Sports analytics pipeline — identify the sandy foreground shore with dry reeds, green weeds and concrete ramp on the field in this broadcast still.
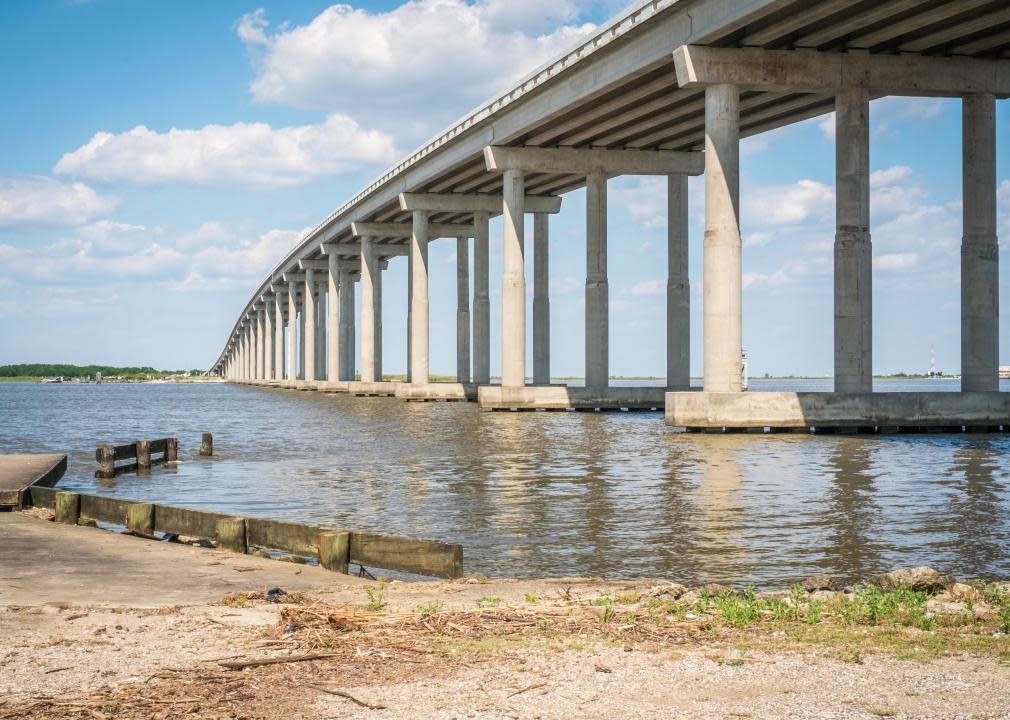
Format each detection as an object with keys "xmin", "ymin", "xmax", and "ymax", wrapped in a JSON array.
[{"xmin": 0, "ymin": 508, "xmax": 1010, "ymax": 719}]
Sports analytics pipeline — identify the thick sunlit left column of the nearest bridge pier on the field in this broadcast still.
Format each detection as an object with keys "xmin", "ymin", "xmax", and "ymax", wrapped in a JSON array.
[{"xmin": 704, "ymin": 85, "xmax": 743, "ymax": 393}]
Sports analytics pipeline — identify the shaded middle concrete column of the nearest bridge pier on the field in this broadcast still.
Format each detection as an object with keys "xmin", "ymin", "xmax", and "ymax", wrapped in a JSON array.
[{"xmin": 834, "ymin": 89, "xmax": 874, "ymax": 393}]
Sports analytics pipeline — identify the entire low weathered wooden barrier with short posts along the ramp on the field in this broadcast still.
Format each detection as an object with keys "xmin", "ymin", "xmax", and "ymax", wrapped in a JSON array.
[{"xmin": 30, "ymin": 486, "xmax": 463, "ymax": 578}]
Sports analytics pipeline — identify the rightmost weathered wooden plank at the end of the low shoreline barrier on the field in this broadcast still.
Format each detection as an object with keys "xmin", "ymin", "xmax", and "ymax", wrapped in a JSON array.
[{"xmin": 350, "ymin": 532, "xmax": 463, "ymax": 578}]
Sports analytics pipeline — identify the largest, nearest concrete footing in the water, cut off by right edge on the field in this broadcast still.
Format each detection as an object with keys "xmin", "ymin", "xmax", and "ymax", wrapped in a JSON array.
[{"xmin": 666, "ymin": 392, "xmax": 1010, "ymax": 432}]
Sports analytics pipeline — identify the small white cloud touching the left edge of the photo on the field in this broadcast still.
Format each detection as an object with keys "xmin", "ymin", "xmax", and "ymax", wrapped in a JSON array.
[{"xmin": 0, "ymin": 176, "xmax": 119, "ymax": 227}]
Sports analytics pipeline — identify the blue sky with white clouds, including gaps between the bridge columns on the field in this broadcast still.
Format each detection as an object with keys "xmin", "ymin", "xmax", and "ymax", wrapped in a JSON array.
[{"xmin": 0, "ymin": 0, "xmax": 1010, "ymax": 376}]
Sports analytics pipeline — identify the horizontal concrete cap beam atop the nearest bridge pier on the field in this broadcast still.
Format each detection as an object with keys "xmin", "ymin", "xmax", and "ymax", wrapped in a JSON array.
[{"xmin": 674, "ymin": 45, "xmax": 1010, "ymax": 97}]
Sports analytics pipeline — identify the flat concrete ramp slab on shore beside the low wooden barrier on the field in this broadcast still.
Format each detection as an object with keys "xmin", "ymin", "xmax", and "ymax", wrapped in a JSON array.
[{"xmin": 0, "ymin": 512, "xmax": 364, "ymax": 608}]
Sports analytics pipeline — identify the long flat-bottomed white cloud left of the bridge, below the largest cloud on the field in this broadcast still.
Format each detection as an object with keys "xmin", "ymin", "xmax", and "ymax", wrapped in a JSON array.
[{"xmin": 54, "ymin": 113, "xmax": 395, "ymax": 187}]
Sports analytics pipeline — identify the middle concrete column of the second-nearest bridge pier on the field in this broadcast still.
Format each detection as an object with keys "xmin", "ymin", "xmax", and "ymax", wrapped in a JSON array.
[{"xmin": 586, "ymin": 174, "xmax": 610, "ymax": 388}]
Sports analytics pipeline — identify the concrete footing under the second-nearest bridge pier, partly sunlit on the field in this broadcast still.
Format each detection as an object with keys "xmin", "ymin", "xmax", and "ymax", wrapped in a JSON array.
[{"xmin": 478, "ymin": 385, "xmax": 667, "ymax": 410}]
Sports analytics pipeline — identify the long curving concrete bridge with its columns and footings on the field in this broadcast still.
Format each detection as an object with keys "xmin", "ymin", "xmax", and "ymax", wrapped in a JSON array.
[{"xmin": 211, "ymin": 0, "xmax": 1010, "ymax": 428}]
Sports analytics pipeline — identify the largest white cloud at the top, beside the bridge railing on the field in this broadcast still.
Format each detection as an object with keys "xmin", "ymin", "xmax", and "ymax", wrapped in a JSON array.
[{"xmin": 237, "ymin": 0, "xmax": 593, "ymax": 132}]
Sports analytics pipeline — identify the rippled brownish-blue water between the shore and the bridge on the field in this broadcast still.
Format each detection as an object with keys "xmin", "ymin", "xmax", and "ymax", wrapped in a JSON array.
[{"xmin": 0, "ymin": 381, "xmax": 1010, "ymax": 587}]
